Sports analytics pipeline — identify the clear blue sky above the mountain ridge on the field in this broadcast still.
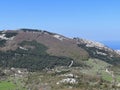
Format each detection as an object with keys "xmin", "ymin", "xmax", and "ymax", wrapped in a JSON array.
[{"xmin": 0, "ymin": 0, "xmax": 120, "ymax": 41}]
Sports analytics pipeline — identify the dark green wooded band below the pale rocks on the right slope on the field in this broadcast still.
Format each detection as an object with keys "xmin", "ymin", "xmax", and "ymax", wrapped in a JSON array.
[{"xmin": 78, "ymin": 44, "xmax": 120, "ymax": 65}]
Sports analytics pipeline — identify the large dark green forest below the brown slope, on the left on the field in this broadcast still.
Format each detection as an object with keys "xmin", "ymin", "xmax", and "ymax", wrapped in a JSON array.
[{"xmin": 0, "ymin": 41, "xmax": 81, "ymax": 71}]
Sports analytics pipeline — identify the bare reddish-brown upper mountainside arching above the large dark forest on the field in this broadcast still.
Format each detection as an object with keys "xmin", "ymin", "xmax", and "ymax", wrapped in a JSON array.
[{"xmin": 1, "ymin": 29, "xmax": 88, "ymax": 59}]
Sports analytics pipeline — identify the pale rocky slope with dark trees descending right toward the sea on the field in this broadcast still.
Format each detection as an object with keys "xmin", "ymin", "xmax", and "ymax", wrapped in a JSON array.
[{"xmin": 74, "ymin": 38, "xmax": 120, "ymax": 65}]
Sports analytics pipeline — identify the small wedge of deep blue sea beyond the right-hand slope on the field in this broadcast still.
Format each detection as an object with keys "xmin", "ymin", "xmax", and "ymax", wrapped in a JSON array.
[{"xmin": 102, "ymin": 41, "xmax": 120, "ymax": 50}]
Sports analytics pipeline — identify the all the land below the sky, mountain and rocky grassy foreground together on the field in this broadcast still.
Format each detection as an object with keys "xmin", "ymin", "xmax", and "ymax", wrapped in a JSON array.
[{"xmin": 0, "ymin": 29, "xmax": 120, "ymax": 90}]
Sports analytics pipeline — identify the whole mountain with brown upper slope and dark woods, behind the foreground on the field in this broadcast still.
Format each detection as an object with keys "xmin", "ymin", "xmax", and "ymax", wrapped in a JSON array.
[{"xmin": 0, "ymin": 29, "xmax": 120, "ymax": 70}]
